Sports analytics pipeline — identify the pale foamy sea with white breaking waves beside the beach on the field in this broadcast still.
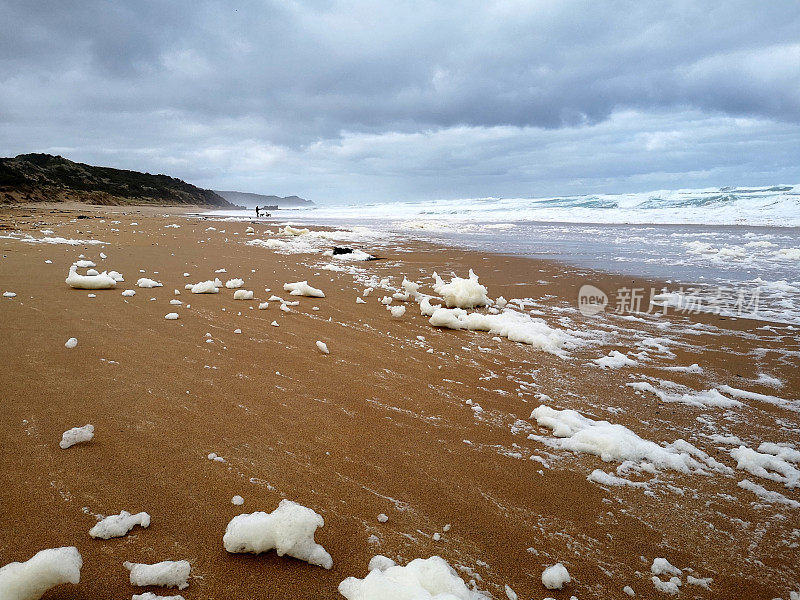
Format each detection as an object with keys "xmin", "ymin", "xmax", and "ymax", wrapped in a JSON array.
[{"xmin": 206, "ymin": 185, "xmax": 800, "ymax": 325}]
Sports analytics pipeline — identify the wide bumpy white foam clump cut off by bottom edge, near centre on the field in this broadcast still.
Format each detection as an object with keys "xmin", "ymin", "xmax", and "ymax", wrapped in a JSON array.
[{"xmin": 339, "ymin": 555, "xmax": 489, "ymax": 600}]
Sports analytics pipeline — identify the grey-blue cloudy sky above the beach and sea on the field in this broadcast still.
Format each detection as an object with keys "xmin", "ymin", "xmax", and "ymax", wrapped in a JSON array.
[{"xmin": 0, "ymin": 0, "xmax": 800, "ymax": 203}]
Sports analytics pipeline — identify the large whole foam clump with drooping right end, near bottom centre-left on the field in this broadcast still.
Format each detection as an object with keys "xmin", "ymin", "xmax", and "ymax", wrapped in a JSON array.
[{"xmin": 222, "ymin": 499, "xmax": 333, "ymax": 569}]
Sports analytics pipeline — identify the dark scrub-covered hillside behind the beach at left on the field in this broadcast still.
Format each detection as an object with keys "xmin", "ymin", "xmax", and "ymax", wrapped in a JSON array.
[{"xmin": 0, "ymin": 154, "xmax": 231, "ymax": 207}]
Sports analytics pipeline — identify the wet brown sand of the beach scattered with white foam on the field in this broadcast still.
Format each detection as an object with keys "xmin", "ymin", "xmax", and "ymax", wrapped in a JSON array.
[{"xmin": 0, "ymin": 205, "xmax": 800, "ymax": 600}]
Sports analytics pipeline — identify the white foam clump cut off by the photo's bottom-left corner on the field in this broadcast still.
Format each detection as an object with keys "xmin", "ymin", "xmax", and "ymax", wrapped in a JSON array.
[{"xmin": 0, "ymin": 546, "xmax": 83, "ymax": 600}]
